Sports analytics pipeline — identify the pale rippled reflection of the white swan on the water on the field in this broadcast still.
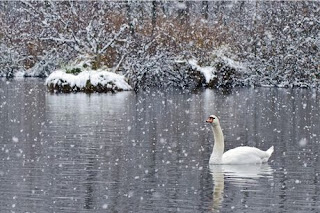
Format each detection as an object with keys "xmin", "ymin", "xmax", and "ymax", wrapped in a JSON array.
[{"xmin": 210, "ymin": 164, "xmax": 273, "ymax": 212}]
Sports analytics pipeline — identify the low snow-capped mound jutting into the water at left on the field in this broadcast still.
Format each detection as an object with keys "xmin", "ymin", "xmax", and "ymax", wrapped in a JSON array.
[{"xmin": 45, "ymin": 70, "xmax": 132, "ymax": 92}]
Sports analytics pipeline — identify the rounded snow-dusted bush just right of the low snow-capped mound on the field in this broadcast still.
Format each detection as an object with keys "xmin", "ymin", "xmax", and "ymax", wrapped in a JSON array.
[{"xmin": 124, "ymin": 53, "xmax": 205, "ymax": 90}]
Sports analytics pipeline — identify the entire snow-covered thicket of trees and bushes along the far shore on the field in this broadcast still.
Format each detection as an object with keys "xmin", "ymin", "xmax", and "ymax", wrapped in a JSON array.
[{"xmin": 0, "ymin": 0, "xmax": 320, "ymax": 88}]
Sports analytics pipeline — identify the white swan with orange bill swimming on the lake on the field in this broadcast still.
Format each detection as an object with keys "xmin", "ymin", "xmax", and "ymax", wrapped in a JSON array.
[{"xmin": 206, "ymin": 115, "xmax": 274, "ymax": 164}]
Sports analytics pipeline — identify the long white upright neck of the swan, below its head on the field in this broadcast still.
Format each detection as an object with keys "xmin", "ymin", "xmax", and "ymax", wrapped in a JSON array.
[{"xmin": 210, "ymin": 125, "xmax": 224, "ymax": 164}]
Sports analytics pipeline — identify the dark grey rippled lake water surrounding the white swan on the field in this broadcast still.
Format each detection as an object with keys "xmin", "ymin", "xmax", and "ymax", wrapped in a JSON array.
[{"xmin": 0, "ymin": 79, "xmax": 320, "ymax": 213}]
